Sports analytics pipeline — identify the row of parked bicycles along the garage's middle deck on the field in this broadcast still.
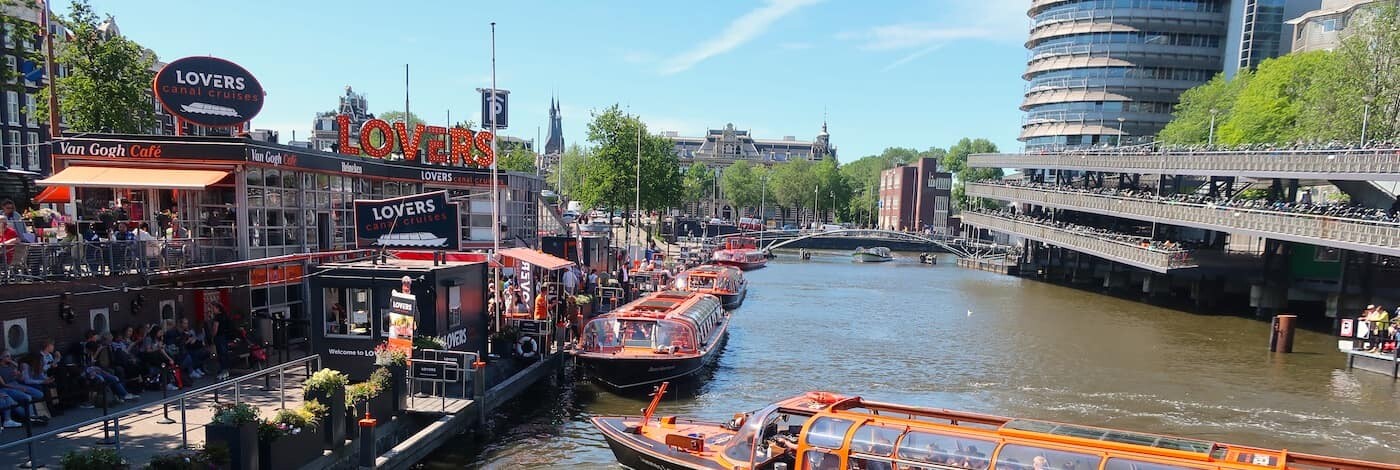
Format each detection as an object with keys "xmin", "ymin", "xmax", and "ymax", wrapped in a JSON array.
[{"xmin": 979, "ymin": 180, "xmax": 1400, "ymax": 224}]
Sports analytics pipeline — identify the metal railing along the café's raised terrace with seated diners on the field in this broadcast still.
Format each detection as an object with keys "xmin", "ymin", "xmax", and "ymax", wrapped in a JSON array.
[{"xmin": 0, "ymin": 238, "xmax": 238, "ymax": 284}]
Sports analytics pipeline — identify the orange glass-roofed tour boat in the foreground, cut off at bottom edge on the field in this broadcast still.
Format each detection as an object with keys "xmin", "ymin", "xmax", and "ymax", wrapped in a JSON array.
[{"xmin": 592, "ymin": 385, "xmax": 1400, "ymax": 470}]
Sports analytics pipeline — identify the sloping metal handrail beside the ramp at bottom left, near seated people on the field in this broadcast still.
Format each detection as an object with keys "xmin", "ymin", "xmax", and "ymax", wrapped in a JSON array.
[{"xmin": 0, "ymin": 354, "xmax": 321, "ymax": 469}]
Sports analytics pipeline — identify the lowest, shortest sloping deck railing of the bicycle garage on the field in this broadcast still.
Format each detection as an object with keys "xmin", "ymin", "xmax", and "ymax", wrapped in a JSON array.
[{"xmin": 962, "ymin": 211, "xmax": 1196, "ymax": 273}]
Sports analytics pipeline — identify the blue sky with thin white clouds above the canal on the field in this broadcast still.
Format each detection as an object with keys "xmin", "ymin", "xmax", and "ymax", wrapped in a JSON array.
[{"xmin": 84, "ymin": 0, "xmax": 1026, "ymax": 162}]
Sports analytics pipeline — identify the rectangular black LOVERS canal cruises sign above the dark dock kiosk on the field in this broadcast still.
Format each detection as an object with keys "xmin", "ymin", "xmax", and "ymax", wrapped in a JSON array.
[{"xmin": 354, "ymin": 192, "xmax": 462, "ymax": 250}]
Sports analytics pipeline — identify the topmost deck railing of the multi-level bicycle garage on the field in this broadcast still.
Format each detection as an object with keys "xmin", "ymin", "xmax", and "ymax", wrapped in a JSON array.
[{"xmin": 967, "ymin": 148, "xmax": 1400, "ymax": 180}]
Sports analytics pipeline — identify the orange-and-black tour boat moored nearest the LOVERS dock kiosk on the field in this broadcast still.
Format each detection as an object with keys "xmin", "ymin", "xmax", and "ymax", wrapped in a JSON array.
[{"xmin": 574, "ymin": 291, "xmax": 729, "ymax": 392}]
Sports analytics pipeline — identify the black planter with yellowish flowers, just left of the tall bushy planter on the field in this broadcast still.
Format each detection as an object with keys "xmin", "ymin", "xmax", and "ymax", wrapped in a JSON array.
[{"xmin": 258, "ymin": 400, "xmax": 326, "ymax": 469}]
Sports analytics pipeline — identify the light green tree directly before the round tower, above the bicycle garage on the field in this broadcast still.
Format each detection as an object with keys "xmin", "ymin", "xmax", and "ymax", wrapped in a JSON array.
[{"xmin": 1156, "ymin": 70, "xmax": 1254, "ymax": 144}]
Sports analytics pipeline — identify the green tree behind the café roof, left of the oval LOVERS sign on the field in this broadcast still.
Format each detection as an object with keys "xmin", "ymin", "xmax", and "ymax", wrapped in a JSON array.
[{"xmin": 38, "ymin": 0, "xmax": 155, "ymax": 134}]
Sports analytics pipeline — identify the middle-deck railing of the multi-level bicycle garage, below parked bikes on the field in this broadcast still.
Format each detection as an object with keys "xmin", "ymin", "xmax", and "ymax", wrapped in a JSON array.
[{"xmin": 965, "ymin": 183, "xmax": 1400, "ymax": 256}]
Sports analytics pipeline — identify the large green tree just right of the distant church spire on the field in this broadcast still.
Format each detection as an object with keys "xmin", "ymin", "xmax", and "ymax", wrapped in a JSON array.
[{"xmin": 578, "ymin": 105, "xmax": 682, "ymax": 210}]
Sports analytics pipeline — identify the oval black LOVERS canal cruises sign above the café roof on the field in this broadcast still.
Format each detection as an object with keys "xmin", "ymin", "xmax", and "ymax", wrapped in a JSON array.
[{"xmin": 155, "ymin": 56, "xmax": 263, "ymax": 127}]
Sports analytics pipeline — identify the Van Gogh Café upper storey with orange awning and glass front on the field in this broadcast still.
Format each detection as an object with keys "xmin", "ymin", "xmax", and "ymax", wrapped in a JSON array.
[{"xmin": 38, "ymin": 134, "xmax": 524, "ymax": 262}]
